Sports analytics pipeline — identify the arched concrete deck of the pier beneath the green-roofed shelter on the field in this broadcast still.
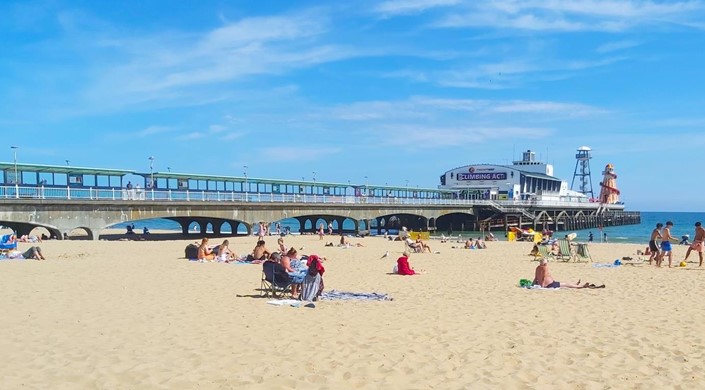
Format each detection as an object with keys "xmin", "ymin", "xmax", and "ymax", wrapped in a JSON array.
[{"xmin": 0, "ymin": 187, "xmax": 641, "ymax": 239}]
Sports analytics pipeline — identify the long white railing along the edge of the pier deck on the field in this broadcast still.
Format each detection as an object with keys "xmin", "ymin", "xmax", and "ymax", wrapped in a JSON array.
[{"xmin": 0, "ymin": 185, "xmax": 624, "ymax": 211}]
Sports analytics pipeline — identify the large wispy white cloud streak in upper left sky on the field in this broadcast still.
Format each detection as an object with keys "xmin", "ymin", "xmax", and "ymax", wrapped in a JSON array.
[{"xmin": 80, "ymin": 12, "xmax": 360, "ymax": 110}]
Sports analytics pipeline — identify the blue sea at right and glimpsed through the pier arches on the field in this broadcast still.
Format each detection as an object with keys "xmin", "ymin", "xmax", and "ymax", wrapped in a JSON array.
[{"xmin": 111, "ymin": 211, "xmax": 705, "ymax": 244}]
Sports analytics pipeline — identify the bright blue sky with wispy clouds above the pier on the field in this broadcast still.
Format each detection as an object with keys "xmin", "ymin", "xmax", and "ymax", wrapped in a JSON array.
[{"xmin": 0, "ymin": 0, "xmax": 705, "ymax": 211}]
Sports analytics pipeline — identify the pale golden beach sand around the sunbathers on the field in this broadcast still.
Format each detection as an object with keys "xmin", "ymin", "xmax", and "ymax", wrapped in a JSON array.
[{"xmin": 0, "ymin": 236, "xmax": 705, "ymax": 389}]
